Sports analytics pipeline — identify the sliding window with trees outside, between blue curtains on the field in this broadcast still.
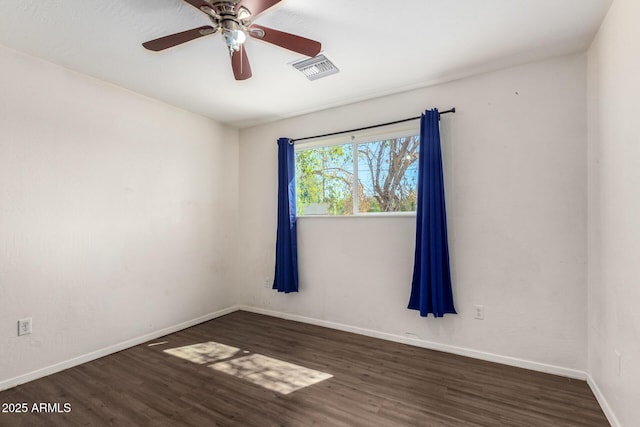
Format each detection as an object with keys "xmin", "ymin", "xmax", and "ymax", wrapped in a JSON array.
[{"xmin": 296, "ymin": 125, "xmax": 420, "ymax": 216}]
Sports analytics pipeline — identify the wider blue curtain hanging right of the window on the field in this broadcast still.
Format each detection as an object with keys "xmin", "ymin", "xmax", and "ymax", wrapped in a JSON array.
[{"xmin": 408, "ymin": 109, "xmax": 456, "ymax": 317}]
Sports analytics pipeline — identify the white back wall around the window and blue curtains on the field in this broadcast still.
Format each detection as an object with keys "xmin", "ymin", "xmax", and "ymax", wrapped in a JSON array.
[{"xmin": 239, "ymin": 55, "xmax": 587, "ymax": 374}]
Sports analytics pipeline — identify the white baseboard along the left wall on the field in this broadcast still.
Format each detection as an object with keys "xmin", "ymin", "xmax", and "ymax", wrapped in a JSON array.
[{"xmin": 0, "ymin": 306, "xmax": 239, "ymax": 391}]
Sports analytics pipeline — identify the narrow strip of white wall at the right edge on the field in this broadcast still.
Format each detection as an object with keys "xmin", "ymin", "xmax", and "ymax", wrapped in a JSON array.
[{"xmin": 588, "ymin": 0, "xmax": 640, "ymax": 426}]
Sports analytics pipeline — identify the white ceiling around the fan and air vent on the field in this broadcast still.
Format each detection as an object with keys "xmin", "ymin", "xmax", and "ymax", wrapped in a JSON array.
[{"xmin": 0, "ymin": 0, "xmax": 611, "ymax": 127}]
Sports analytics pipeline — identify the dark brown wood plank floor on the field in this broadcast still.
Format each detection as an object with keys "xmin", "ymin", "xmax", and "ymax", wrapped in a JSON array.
[{"xmin": 0, "ymin": 312, "xmax": 609, "ymax": 427}]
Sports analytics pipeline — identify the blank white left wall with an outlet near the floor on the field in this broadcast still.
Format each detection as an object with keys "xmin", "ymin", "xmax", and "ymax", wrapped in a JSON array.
[{"xmin": 0, "ymin": 47, "xmax": 238, "ymax": 388}]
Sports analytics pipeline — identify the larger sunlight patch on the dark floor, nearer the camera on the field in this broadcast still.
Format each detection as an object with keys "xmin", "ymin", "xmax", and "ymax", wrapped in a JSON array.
[{"xmin": 210, "ymin": 354, "xmax": 333, "ymax": 394}]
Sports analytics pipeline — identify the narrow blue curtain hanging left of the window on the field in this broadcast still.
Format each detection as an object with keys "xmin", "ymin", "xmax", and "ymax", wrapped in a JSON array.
[{"xmin": 273, "ymin": 138, "xmax": 298, "ymax": 294}]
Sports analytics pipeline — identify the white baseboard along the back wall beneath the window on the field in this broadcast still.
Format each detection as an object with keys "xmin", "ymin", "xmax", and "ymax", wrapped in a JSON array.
[{"xmin": 238, "ymin": 305, "xmax": 587, "ymax": 380}]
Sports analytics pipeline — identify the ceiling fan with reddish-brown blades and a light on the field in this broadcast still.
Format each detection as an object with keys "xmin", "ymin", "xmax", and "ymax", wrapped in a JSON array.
[{"xmin": 142, "ymin": 0, "xmax": 322, "ymax": 80}]
